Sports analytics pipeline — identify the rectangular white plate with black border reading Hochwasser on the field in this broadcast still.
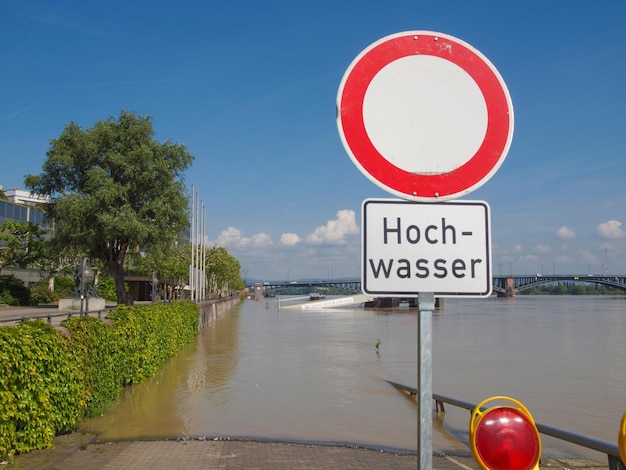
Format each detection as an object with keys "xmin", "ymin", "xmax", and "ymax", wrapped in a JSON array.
[{"xmin": 361, "ymin": 199, "xmax": 492, "ymax": 297}]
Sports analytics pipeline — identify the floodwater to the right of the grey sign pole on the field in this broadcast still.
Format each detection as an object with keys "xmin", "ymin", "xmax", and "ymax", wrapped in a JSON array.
[{"xmin": 433, "ymin": 296, "xmax": 626, "ymax": 461}]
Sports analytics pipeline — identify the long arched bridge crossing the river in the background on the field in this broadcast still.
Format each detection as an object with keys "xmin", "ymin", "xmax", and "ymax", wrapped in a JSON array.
[{"xmin": 249, "ymin": 274, "xmax": 626, "ymax": 297}]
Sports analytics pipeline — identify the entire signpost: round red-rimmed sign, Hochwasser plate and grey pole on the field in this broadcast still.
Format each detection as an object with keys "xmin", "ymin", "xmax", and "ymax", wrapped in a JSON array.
[{"xmin": 337, "ymin": 31, "xmax": 514, "ymax": 469}]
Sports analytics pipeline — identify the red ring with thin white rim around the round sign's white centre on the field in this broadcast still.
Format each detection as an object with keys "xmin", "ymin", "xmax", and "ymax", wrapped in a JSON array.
[{"xmin": 337, "ymin": 31, "xmax": 513, "ymax": 202}]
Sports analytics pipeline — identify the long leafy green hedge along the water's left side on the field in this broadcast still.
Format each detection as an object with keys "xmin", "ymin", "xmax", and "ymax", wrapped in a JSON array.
[{"xmin": 0, "ymin": 302, "xmax": 198, "ymax": 457}]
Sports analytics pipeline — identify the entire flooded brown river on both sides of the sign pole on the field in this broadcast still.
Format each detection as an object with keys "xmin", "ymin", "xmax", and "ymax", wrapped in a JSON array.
[{"xmin": 82, "ymin": 296, "xmax": 626, "ymax": 460}]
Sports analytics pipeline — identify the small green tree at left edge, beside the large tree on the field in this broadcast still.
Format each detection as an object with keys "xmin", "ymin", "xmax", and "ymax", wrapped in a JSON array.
[{"xmin": 0, "ymin": 220, "xmax": 46, "ymax": 268}]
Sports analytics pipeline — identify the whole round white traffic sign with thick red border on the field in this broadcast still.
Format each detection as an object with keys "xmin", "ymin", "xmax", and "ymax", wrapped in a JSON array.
[{"xmin": 337, "ymin": 31, "xmax": 513, "ymax": 202}]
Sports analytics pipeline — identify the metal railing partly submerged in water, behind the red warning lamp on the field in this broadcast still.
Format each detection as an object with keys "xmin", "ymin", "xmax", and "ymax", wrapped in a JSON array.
[{"xmin": 387, "ymin": 380, "xmax": 626, "ymax": 470}]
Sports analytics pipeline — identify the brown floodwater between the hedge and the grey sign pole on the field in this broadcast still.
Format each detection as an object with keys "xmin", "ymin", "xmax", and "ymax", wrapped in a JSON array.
[{"xmin": 81, "ymin": 301, "xmax": 418, "ymax": 451}]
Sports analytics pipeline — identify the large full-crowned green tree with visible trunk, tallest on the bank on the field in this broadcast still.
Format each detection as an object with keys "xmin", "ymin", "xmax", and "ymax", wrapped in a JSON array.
[{"xmin": 25, "ymin": 111, "xmax": 193, "ymax": 304}]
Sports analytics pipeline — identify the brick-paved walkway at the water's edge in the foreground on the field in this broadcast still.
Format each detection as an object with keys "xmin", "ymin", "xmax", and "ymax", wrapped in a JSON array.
[{"xmin": 6, "ymin": 433, "xmax": 608, "ymax": 470}]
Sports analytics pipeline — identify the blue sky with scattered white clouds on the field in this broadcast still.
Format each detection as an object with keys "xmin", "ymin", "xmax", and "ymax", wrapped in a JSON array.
[{"xmin": 0, "ymin": 0, "xmax": 626, "ymax": 280}]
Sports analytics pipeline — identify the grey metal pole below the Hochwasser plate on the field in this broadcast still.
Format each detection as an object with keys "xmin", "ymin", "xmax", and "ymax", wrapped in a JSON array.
[{"xmin": 417, "ymin": 292, "xmax": 435, "ymax": 470}]
